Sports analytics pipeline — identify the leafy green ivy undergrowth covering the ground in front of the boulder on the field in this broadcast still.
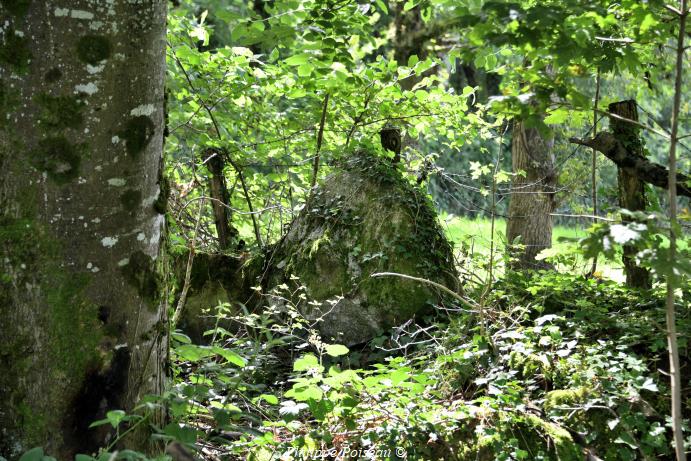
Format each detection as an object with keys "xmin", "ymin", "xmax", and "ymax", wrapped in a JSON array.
[{"xmin": 14, "ymin": 272, "xmax": 691, "ymax": 461}]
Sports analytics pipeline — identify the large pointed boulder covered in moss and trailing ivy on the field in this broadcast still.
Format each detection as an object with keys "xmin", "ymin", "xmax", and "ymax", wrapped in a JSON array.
[{"xmin": 270, "ymin": 152, "xmax": 457, "ymax": 344}]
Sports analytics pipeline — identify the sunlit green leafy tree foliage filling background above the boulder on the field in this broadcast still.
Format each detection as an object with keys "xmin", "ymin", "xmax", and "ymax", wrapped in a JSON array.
[{"xmin": 167, "ymin": 1, "xmax": 689, "ymax": 255}]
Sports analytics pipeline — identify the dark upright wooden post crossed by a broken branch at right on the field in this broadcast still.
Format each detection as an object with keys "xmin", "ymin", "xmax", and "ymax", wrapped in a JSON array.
[{"xmin": 608, "ymin": 100, "xmax": 651, "ymax": 289}]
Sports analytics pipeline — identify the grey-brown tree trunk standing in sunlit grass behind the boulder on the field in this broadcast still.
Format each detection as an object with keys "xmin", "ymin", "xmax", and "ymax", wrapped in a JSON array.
[{"xmin": 506, "ymin": 121, "xmax": 556, "ymax": 269}]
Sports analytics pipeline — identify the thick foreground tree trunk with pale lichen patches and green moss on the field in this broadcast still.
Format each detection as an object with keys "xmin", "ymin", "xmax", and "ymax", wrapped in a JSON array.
[{"xmin": 0, "ymin": 0, "xmax": 167, "ymax": 460}]
